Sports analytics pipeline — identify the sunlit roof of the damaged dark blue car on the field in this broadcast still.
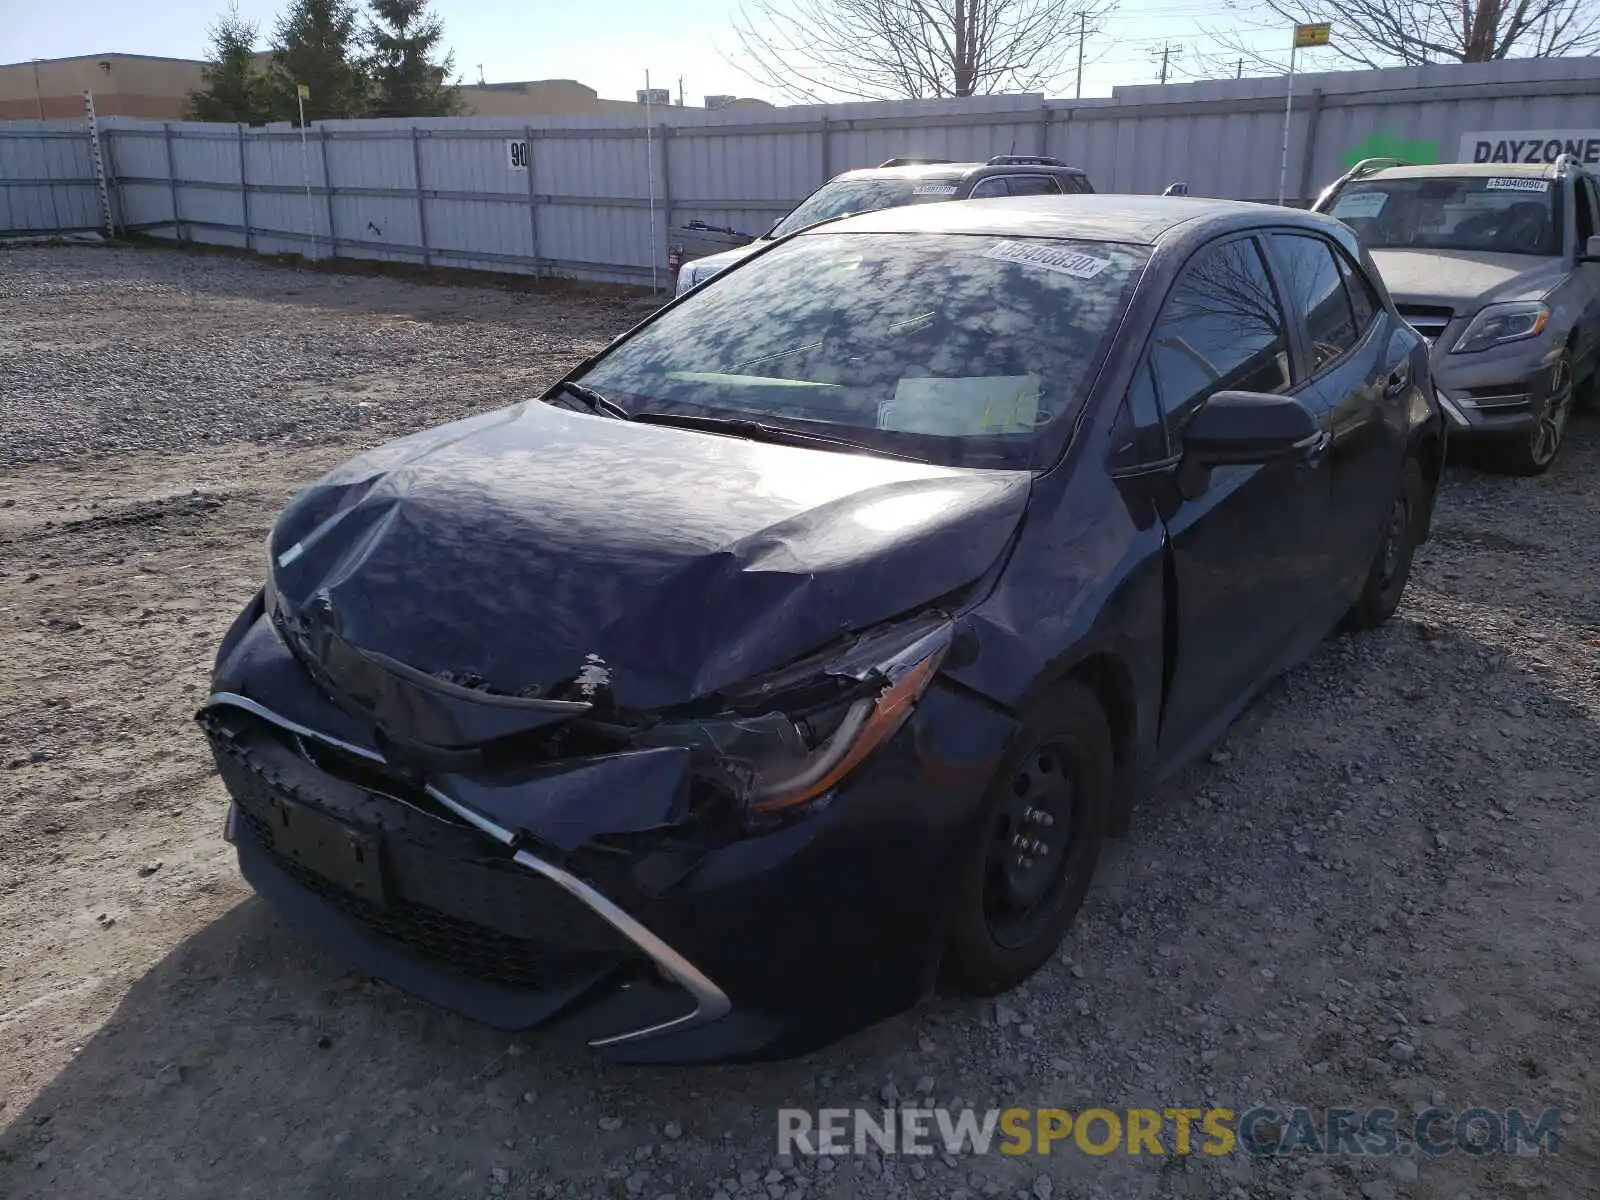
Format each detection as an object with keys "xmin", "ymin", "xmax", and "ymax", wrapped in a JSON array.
[{"xmin": 812, "ymin": 195, "xmax": 1338, "ymax": 245}]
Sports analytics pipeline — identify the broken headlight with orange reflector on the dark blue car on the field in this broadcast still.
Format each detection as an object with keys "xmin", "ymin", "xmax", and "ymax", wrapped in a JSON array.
[{"xmin": 638, "ymin": 614, "xmax": 954, "ymax": 813}]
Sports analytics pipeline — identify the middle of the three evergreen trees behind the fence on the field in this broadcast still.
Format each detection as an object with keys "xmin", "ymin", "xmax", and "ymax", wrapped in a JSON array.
[{"xmin": 269, "ymin": 0, "xmax": 371, "ymax": 122}]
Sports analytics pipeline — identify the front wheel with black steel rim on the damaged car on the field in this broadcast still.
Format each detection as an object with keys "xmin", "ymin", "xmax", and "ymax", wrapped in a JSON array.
[{"xmin": 942, "ymin": 683, "xmax": 1114, "ymax": 995}]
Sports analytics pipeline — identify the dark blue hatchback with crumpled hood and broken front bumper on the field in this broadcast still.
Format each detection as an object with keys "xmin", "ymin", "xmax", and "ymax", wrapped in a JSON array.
[{"xmin": 198, "ymin": 195, "xmax": 1445, "ymax": 1062}]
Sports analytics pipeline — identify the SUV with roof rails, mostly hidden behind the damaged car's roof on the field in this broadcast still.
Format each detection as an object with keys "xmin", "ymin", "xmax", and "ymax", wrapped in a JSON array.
[{"xmin": 677, "ymin": 154, "xmax": 1094, "ymax": 296}]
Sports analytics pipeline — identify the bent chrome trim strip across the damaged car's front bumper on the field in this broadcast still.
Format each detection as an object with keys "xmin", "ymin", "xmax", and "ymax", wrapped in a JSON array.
[{"xmin": 206, "ymin": 691, "xmax": 733, "ymax": 1048}]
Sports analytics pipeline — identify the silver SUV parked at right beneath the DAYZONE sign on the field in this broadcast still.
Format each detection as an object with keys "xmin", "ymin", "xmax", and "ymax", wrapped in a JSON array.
[{"xmin": 1312, "ymin": 155, "xmax": 1600, "ymax": 475}]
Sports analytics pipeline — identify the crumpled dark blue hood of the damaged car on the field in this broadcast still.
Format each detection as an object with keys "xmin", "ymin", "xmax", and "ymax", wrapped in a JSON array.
[{"xmin": 270, "ymin": 402, "xmax": 1030, "ymax": 710}]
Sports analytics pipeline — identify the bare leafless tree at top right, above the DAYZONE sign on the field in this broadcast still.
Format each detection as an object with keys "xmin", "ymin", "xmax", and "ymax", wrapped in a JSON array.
[{"xmin": 1206, "ymin": 0, "xmax": 1600, "ymax": 75}]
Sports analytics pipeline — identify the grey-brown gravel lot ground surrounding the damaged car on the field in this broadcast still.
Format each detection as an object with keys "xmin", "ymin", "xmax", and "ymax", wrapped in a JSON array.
[{"xmin": 0, "ymin": 248, "xmax": 1600, "ymax": 1200}]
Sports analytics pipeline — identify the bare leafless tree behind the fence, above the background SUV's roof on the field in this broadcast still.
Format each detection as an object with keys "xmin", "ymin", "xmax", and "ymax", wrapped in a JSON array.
[{"xmin": 730, "ymin": 0, "xmax": 1115, "ymax": 101}]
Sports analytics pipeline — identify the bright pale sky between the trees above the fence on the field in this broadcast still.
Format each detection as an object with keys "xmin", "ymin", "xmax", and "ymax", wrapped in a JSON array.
[{"xmin": 0, "ymin": 0, "xmax": 1305, "ymax": 104}]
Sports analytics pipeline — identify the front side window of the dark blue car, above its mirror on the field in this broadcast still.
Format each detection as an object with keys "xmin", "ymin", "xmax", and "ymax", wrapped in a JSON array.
[{"xmin": 1149, "ymin": 237, "xmax": 1291, "ymax": 434}]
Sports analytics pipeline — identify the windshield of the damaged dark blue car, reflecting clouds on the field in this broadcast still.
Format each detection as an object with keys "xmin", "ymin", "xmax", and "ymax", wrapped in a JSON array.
[{"xmin": 582, "ymin": 234, "xmax": 1147, "ymax": 469}]
